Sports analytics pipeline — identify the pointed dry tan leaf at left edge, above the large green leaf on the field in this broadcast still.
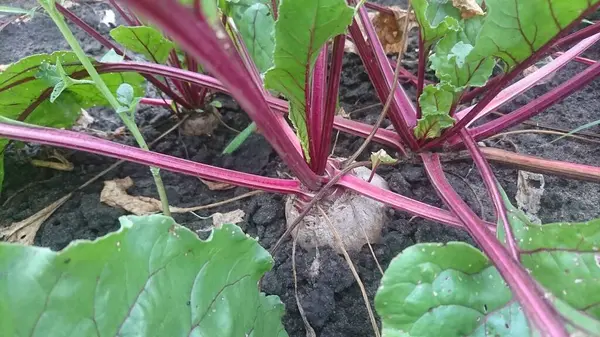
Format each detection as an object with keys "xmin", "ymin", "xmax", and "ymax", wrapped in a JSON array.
[{"xmin": 0, "ymin": 193, "xmax": 71, "ymax": 246}]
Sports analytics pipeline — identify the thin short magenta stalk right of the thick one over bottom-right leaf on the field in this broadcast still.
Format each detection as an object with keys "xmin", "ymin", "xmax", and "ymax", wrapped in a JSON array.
[{"xmin": 460, "ymin": 129, "xmax": 519, "ymax": 261}]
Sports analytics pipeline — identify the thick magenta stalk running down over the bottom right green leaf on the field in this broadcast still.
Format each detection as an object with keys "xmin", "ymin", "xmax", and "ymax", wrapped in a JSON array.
[{"xmin": 421, "ymin": 153, "xmax": 569, "ymax": 337}]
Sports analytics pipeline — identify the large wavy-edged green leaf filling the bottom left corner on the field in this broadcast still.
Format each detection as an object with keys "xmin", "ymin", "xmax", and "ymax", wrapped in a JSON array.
[{"xmin": 0, "ymin": 215, "xmax": 287, "ymax": 337}]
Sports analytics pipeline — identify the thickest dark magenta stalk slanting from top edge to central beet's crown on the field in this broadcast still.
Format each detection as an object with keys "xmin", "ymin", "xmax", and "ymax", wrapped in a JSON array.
[{"xmin": 119, "ymin": 0, "xmax": 321, "ymax": 190}]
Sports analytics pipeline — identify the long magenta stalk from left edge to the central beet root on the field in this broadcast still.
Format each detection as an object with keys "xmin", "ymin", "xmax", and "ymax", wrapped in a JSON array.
[{"xmin": 0, "ymin": 123, "xmax": 310, "ymax": 197}]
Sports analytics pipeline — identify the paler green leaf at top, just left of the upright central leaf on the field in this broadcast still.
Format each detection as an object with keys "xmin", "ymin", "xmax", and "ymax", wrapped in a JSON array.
[{"xmin": 221, "ymin": 0, "xmax": 275, "ymax": 74}]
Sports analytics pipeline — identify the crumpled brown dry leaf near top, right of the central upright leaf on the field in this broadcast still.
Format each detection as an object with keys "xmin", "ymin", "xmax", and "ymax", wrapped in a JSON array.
[{"xmin": 371, "ymin": 6, "xmax": 417, "ymax": 54}]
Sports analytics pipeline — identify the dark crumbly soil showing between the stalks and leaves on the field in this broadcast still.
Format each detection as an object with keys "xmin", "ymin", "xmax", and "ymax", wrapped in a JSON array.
[{"xmin": 0, "ymin": 1, "xmax": 600, "ymax": 337}]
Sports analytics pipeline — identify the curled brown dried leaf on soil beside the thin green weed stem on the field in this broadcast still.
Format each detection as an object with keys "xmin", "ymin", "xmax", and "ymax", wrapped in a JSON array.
[{"xmin": 100, "ymin": 177, "xmax": 162, "ymax": 215}]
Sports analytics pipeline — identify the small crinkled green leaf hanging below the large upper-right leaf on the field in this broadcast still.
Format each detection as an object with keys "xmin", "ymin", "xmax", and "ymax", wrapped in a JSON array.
[{"xmin": 414, "ymin": 84, "xmax": 456, "ymax": 139}]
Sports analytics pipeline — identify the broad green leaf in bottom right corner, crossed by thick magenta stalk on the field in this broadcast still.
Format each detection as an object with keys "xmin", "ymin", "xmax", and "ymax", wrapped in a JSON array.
[{"xmin": 375, "ymin": 190, "xmax": 600, "ymax": 337}]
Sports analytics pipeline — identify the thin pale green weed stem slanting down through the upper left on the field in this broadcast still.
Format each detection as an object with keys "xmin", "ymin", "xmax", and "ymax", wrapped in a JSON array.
[{"xmin": 39, "ymin": 0, "xmax": 171, "ymax": 216}]
